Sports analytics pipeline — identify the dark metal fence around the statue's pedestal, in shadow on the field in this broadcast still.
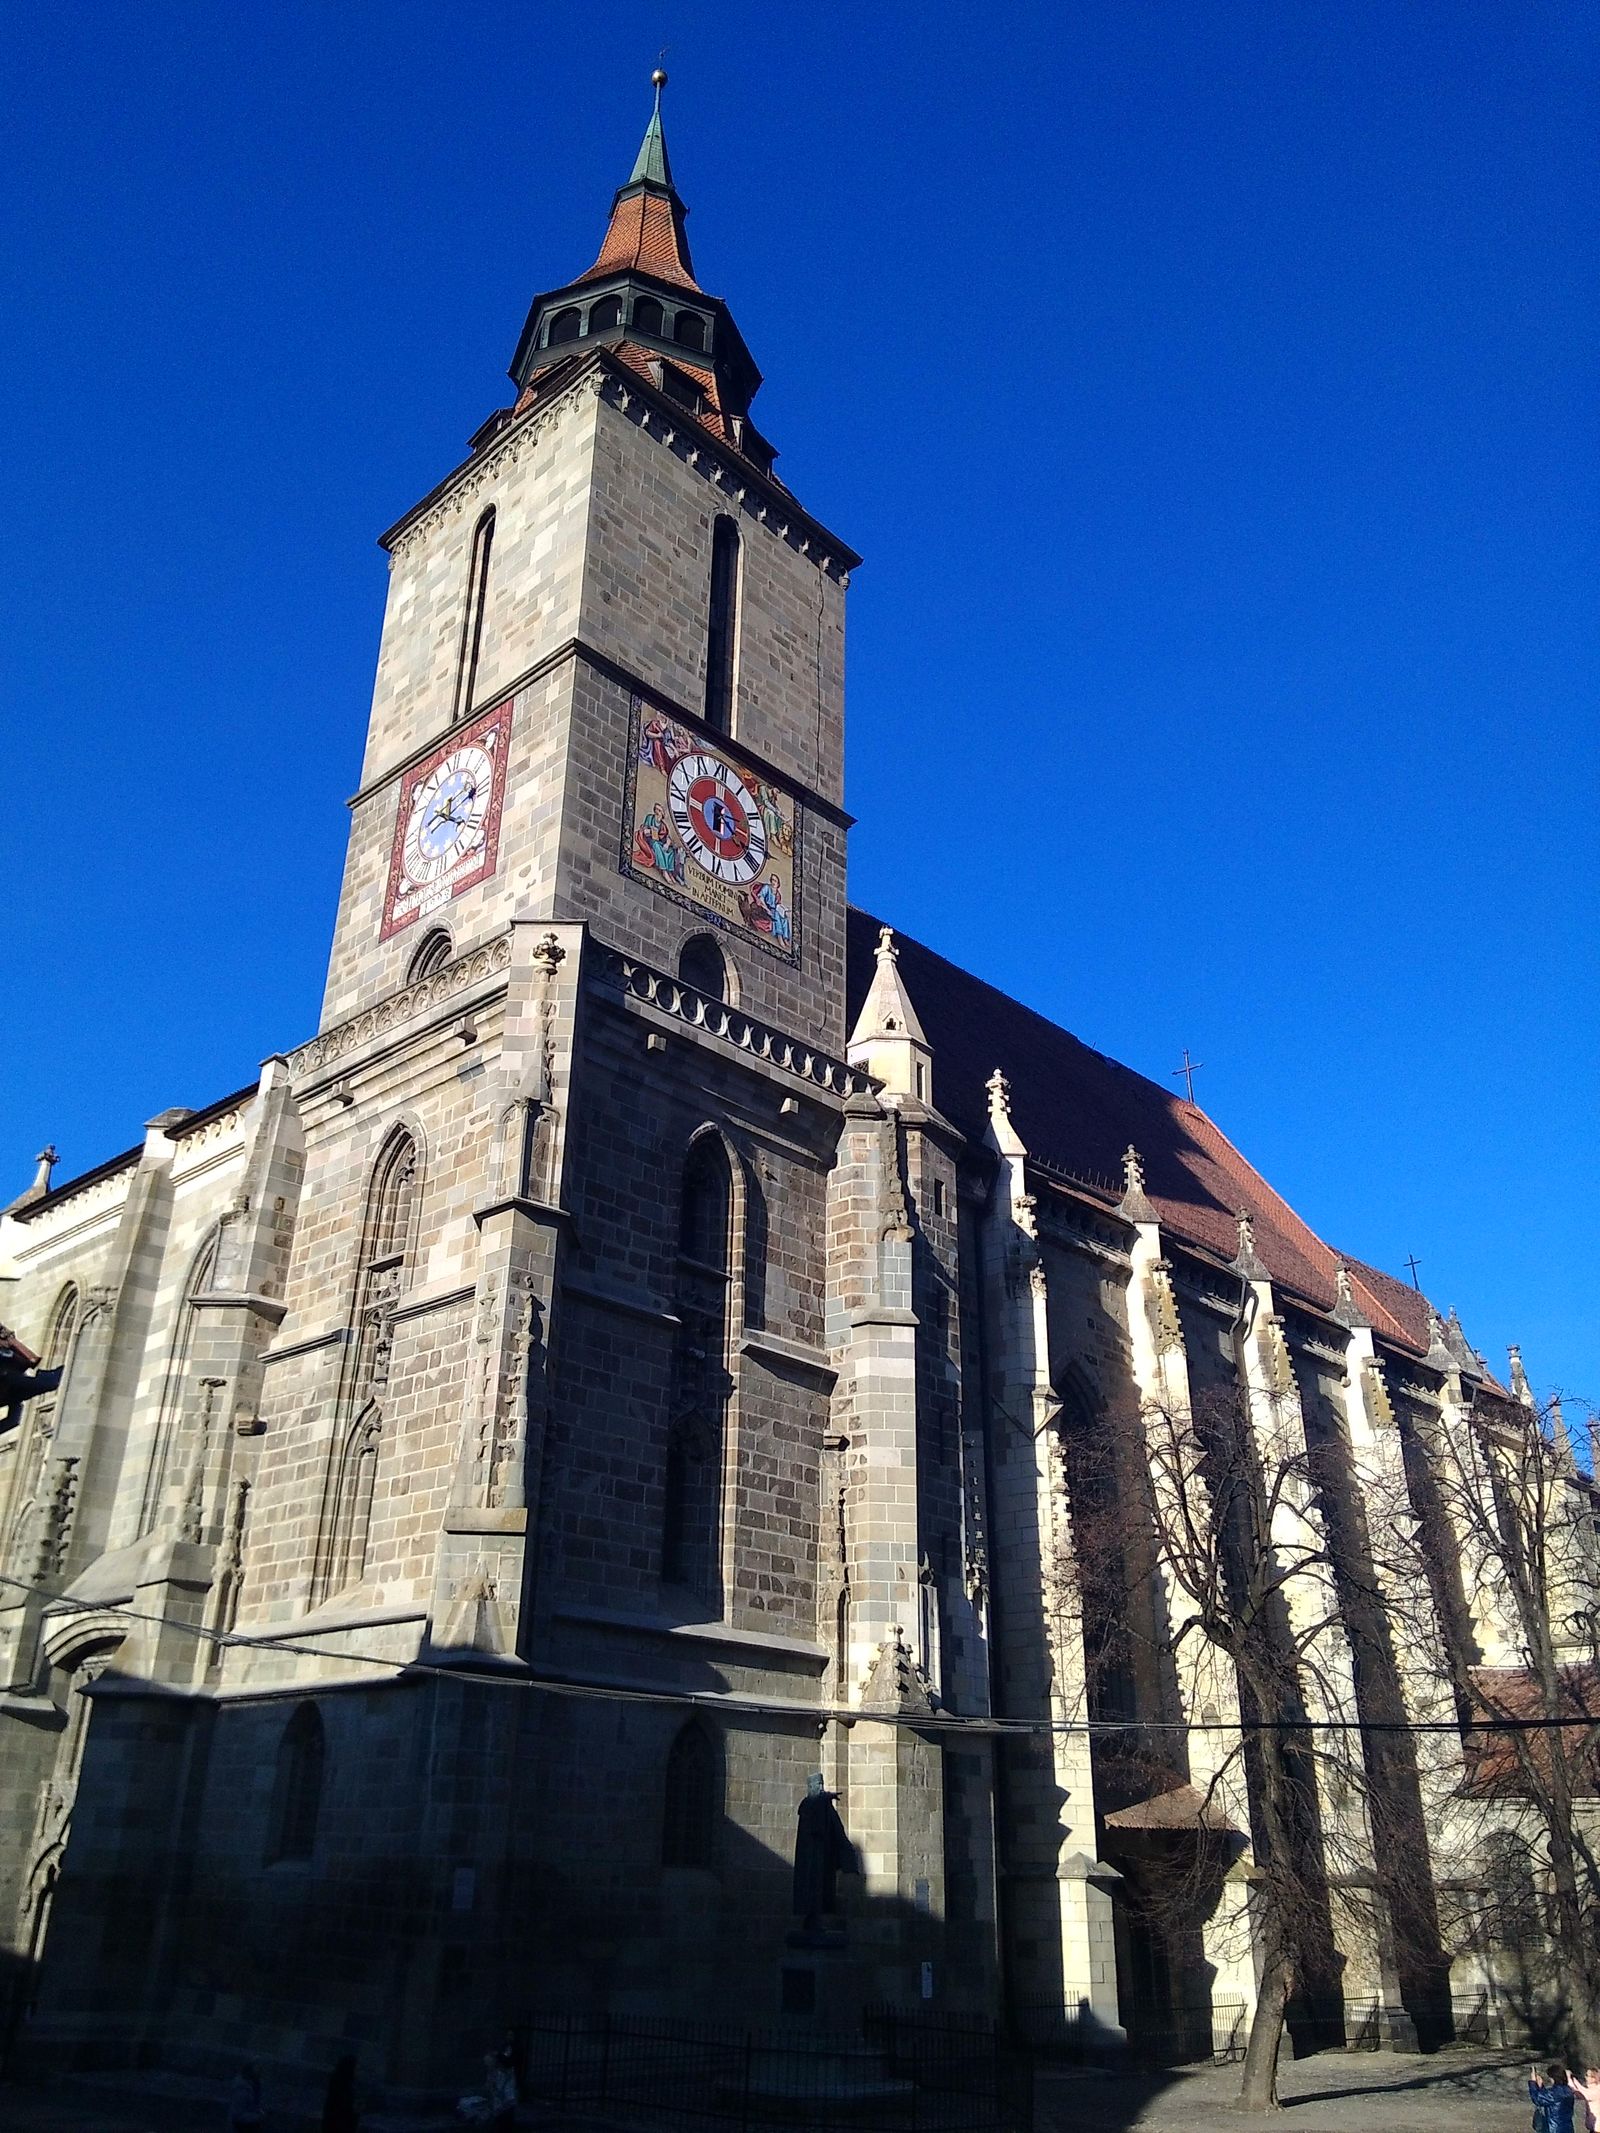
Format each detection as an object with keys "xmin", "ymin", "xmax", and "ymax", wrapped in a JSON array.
[{"xmin": 518, "ymin": 2007, "xmax": 1033, "ymax": 2133}]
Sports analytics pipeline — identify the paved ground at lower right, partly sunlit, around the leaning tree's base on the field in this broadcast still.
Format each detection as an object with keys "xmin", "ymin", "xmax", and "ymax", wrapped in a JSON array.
[{"xmin": 1037, "ymin": 2052, "xmax": 1530, "ymax": 2133}]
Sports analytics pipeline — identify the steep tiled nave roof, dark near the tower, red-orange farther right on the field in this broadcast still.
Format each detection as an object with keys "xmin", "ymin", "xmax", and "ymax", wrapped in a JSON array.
[{"xmin": 849, "ymin": 911, "xmax": 1431, "ymax": 1354}]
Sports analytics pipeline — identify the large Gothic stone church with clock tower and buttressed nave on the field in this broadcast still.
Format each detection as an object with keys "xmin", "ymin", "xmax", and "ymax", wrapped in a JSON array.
[{"xmin": 0, "ymin": 75, "xmax": 1577, "ymax": 2092}]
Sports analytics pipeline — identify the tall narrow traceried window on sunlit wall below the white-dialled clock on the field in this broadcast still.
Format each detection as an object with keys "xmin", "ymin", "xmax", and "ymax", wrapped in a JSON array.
[{"xmin": 311, "ymin": 1126, "xmax": 416, "ymax": 1606}]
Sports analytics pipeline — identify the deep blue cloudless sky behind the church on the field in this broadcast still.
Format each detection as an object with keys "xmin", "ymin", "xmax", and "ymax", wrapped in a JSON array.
[{"xmin": 0, "ymin": 12, "xmax": 1600, "ymax": 1397}]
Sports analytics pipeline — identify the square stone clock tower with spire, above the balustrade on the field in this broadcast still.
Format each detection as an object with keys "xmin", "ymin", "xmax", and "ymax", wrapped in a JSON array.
[{"xmin": 324, "ymin": 75, "xmax": 858, "ymax": 1052}]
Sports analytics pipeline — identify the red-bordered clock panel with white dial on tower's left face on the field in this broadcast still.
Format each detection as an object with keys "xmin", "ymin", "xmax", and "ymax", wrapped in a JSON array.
[{"xmin": 380, "ymin": 704, "xmax": 512, "ymax": 941}]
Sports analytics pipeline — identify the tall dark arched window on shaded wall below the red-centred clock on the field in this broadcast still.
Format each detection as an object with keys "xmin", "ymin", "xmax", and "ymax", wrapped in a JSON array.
[{"xmin": 661, "ymin": 1133, "xmax": 734, "ymax": 1615}]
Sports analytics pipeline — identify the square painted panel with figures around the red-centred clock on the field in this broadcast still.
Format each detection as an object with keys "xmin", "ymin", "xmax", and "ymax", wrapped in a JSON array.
[{"xmin": 621, "ymin": 695, "xmax": 800, "ymax": 962}]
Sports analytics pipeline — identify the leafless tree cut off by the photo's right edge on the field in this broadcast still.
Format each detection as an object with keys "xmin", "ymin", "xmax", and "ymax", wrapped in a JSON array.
[{"xmin": 1410, "ymin": 1367, "xmax": 1600, "ymax": 2058}]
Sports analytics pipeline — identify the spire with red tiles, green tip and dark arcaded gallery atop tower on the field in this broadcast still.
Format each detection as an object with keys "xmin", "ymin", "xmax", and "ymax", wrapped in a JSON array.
[{"xmin": 501, "ymin": 78, "xmax": 777, "ymax": 474}]
